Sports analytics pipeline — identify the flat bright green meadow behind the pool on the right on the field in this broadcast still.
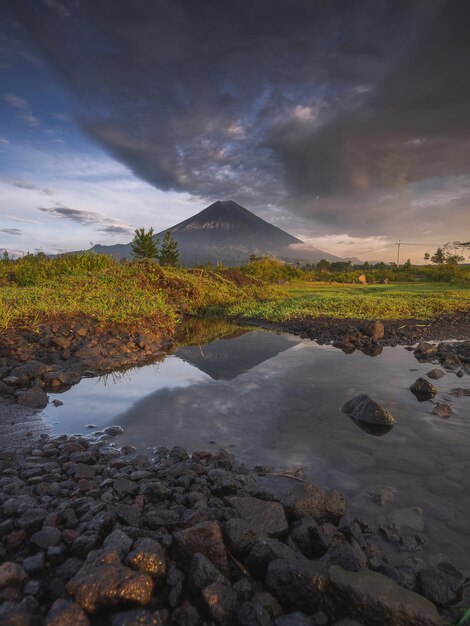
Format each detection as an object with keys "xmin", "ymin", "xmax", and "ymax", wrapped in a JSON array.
[{"xmin": 226, "ymin": 281, "xmax": 470, "ymax": 322}]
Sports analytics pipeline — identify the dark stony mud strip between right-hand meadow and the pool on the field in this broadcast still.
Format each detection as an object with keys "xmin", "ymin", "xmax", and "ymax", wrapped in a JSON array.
[{"xmin": 246, "ymin": 311, "xmax": 470, "ymax": 356}]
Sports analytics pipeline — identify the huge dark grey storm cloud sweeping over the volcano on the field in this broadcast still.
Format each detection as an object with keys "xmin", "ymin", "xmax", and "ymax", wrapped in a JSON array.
[{"xmin": 7, "ymin": 0, "xmax": 470, "ymax": 234}]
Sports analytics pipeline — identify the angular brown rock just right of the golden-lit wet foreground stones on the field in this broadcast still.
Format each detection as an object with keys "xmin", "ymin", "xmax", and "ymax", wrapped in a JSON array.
[{"xmin": 171, "ymin": 521, "xmax": 229, "ymax": 574}]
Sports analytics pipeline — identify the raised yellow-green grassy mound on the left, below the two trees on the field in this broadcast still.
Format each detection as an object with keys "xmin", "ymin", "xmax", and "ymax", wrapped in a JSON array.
[{"xmin": 0, "ymin": 255, "xmax": 272, "ymax": 331}]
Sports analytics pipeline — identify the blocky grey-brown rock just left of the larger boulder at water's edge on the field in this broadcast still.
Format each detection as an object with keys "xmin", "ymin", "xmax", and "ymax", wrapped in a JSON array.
[{"xmin": 228, "ymin": 497, "xmax": 289, "ymax": 538}]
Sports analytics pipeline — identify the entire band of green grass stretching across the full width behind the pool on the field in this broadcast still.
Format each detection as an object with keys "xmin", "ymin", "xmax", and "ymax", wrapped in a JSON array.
[{"xmin": 0, "ymin": 254, "xmax": 470, "ymax": 332}]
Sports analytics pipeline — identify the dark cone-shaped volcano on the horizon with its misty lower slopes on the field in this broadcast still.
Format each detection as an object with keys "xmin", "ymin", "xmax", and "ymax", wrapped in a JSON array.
[{"xmin": 92, "ymin": 200, "xmax": 360, "ymax": 265}]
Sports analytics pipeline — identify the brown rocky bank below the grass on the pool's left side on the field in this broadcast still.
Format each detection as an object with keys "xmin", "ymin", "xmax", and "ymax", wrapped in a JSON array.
[{"xmin": 0, "ymin": 316, "xmax": 174, "ymax": 408}]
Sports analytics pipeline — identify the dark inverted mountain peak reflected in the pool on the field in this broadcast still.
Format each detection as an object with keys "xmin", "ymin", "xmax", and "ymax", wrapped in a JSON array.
[{"xmin": 176, "ymin": 331, "xmax": 300, "ymax": 380}]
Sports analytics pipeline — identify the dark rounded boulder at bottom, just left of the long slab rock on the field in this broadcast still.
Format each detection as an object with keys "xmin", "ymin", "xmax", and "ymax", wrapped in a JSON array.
[{"xmin": 266, "ymin": 559, "xmax": 324, "ymax": 614}]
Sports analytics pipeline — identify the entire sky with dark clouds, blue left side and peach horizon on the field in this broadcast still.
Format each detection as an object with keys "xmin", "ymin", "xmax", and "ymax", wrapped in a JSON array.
[{"xmin": 0, "ymin": 0, "xmax": 470, "ymax": 260}]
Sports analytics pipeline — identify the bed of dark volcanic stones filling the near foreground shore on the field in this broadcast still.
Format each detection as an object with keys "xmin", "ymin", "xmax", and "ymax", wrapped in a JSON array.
[{"xmin": 0, "ymin": 435, "xmax": 468, "ymax": 626}]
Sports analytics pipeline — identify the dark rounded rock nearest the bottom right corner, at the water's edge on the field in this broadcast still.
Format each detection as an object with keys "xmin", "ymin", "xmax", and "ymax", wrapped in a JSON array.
[{"xmin": 418, "ymin": 563, "xmax": 465, "ymax": 606}]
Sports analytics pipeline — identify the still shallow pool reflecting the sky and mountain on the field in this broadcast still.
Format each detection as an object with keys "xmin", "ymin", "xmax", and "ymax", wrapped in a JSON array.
[{"xmin": 44, "ymin": 329, "xmax": 470, "ymax": 571}]
